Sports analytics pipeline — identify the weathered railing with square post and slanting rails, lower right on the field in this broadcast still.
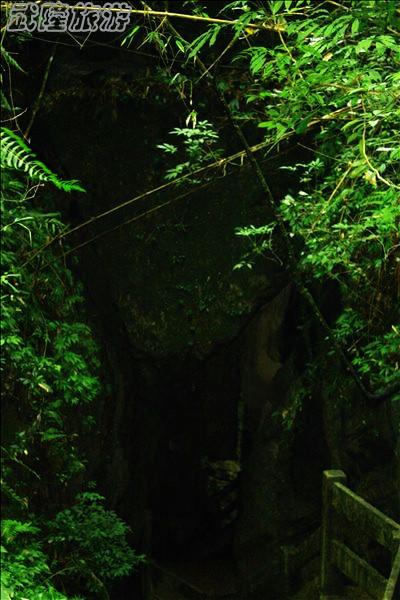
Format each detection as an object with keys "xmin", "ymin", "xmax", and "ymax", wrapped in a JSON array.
[{"xmin": 320, "ymin": 471, "xmax": 400, "ymax": 600}]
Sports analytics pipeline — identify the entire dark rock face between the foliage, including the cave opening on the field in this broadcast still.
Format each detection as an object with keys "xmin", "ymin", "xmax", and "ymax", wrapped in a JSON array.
[{"xmin": 28, "ymin": 41, "xmax": 400, "ymax": 598}]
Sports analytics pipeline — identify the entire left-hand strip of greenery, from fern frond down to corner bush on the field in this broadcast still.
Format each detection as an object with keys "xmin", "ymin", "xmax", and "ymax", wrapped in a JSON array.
[{"xmin": 0, "ymin": 43, "xmax": 142, "ymax": 600}]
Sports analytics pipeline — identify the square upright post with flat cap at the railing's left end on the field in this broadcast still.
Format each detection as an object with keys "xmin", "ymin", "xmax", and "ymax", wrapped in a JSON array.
[{"xmin": 320, "ymin": 470, "xmax": 347, "ymax": 600}]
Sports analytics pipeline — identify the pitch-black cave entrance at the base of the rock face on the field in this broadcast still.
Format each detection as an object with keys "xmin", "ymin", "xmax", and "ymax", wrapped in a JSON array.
[{"xmin": 149, "ymin": 347, "xmax": 240, "ymax": 564}]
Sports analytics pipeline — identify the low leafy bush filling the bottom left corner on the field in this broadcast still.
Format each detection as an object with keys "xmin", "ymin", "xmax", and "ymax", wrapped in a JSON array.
[{"xmin": 1, "ymin": 492, "xmax": 144, "ymax": 600}]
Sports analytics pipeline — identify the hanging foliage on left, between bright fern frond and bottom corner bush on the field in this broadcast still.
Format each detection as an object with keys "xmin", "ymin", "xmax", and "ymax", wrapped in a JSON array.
[{"xmin": 1, "ymin": 164, "xmax": 99, "ymax": 496}]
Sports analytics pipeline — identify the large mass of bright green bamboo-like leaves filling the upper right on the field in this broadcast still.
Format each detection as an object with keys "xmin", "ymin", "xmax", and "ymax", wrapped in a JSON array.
[{"xmin": 126, "ymin": 0, "xmax": 400, "ymax": 410}]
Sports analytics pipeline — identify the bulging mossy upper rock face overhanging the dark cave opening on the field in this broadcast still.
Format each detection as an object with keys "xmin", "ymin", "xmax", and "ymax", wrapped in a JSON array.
[{"xmin": 36, "ymin": 44, "xmax": 288, "ymax": 488}]
